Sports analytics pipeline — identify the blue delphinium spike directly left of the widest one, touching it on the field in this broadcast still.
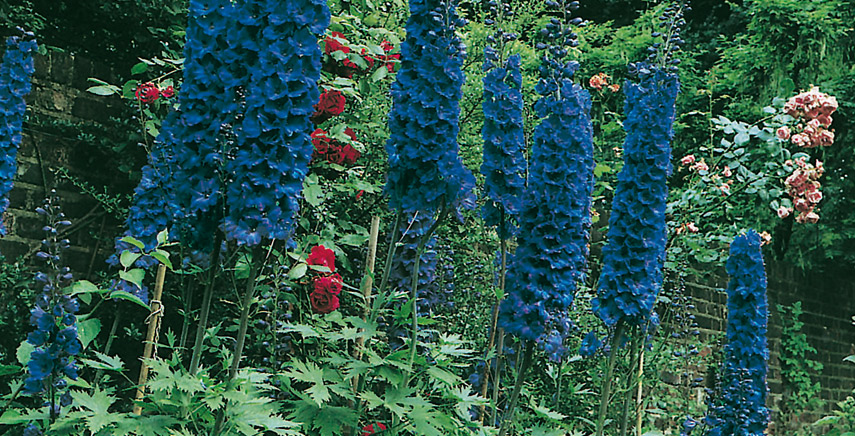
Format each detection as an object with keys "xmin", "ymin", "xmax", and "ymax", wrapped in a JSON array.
[{"xmin": 169, "ymin": 0, "xmax": 246, "ymax": 252}]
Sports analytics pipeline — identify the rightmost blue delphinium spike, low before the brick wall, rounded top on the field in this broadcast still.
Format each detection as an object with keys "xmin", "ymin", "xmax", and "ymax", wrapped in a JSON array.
[{"xmin": 706, "ymin": 230, "xmax": 769, "ymax": 436}]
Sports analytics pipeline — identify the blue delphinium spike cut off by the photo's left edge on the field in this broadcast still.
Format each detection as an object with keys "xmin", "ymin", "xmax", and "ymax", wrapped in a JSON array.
[{"xmin": 0, "ymin": 33, "xmax": 37, "ymax": 236}]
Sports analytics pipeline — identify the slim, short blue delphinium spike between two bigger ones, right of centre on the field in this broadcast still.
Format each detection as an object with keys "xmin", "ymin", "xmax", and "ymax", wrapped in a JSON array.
[{"xmin": 481, "ymin": 0, "xmax": 526, "ymax": 238}]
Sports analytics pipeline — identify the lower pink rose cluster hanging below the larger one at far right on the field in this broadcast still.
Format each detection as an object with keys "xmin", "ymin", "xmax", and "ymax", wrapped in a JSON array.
[{"xmin": 778, "ymin": 159, "xmax": 825, "ymax": 224}]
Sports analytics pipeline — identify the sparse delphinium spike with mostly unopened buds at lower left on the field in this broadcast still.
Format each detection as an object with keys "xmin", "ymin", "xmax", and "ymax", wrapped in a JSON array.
[{"xmin": 24, "ymin": 191, "xmax": 81, "ymax": 419}]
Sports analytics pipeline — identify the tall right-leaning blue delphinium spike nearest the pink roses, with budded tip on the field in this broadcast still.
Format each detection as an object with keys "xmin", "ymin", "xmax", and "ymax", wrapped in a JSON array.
[{"xmin": 591, "ymin": 2, "xmax": 685, "ymax": 327}]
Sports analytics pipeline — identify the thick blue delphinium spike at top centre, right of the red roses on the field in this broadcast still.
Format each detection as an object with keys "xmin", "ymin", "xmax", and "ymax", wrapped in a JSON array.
[{"xmin": 385, "ymin": 0, "xmax": 475, "ymax": 213}]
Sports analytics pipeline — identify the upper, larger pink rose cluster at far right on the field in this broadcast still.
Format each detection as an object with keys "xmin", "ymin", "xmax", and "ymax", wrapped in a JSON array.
[{"xmin": 775, "ymin": 86, "xmax": 837, "ymax": 148}]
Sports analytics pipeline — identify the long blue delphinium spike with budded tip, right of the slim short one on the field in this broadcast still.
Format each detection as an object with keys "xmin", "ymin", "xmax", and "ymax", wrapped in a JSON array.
[{"xmin": 499, "ymin": 2, "xmax": 594, "ymax": 358}]
